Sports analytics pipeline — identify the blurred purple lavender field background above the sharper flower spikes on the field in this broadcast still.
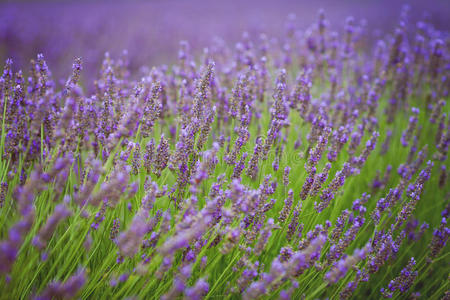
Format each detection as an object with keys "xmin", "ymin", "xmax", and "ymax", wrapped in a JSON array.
[{"xmin": 0, "ymin": 0, "xmax": 450, "ymax": 81}]
